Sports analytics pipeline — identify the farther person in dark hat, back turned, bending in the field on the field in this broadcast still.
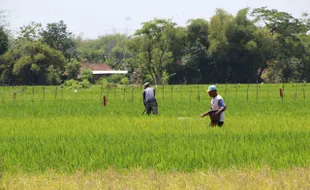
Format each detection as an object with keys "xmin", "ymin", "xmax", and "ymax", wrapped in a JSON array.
[{"xmin": 143, "ymin": 82, "xmax": 158, "ymax": 115}]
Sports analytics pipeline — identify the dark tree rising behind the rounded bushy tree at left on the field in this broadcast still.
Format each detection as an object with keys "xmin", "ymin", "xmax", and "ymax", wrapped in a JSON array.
[{"xmin": 41, "ymin": 21, "xmax": 77, "ymax": 60}]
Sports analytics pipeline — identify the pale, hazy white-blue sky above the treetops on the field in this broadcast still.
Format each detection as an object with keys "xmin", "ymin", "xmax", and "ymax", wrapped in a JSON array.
[{"xmin": 0, "ymin": 0, "xmax": 310, "ymax": 39}]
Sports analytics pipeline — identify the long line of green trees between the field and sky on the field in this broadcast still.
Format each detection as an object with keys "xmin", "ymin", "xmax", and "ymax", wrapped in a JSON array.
[{"xmin": 0, "ymin": 7, "xmax": 310, "ymax": 85}]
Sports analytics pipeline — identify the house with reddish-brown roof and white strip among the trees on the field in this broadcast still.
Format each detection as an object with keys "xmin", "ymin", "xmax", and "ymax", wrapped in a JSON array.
[{"xmin": 78, "ymin": 62, "xmax": 128, "ymax": 81}]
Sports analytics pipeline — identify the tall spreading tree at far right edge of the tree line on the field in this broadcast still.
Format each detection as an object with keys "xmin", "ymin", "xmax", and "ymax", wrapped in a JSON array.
[{"xmin": 252, "ymin": 7, "xmax": 310, "ymax": 82}]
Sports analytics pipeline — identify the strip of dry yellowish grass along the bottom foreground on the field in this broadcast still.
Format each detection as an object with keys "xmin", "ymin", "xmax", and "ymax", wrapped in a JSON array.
[{"xmin": 2, "ymin": 168, "xmax": 310, "ymax": 190}]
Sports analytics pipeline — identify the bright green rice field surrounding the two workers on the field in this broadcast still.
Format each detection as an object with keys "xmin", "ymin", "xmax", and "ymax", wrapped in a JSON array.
[{"xmin": 0, "ymin": 83, "xmax": 310, "ymax": 189}]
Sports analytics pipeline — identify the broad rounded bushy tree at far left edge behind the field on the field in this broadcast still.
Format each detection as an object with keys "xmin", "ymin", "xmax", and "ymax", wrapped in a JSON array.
[{"xmin": 0, "ymin": 41, "xmax": 65, "ymax": 84}]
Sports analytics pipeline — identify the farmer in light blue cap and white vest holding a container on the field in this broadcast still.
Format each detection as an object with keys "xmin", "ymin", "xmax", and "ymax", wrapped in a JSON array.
[{"xmin": 200, "ymin": 85, "xmax": 226, "ymax": 127}]
